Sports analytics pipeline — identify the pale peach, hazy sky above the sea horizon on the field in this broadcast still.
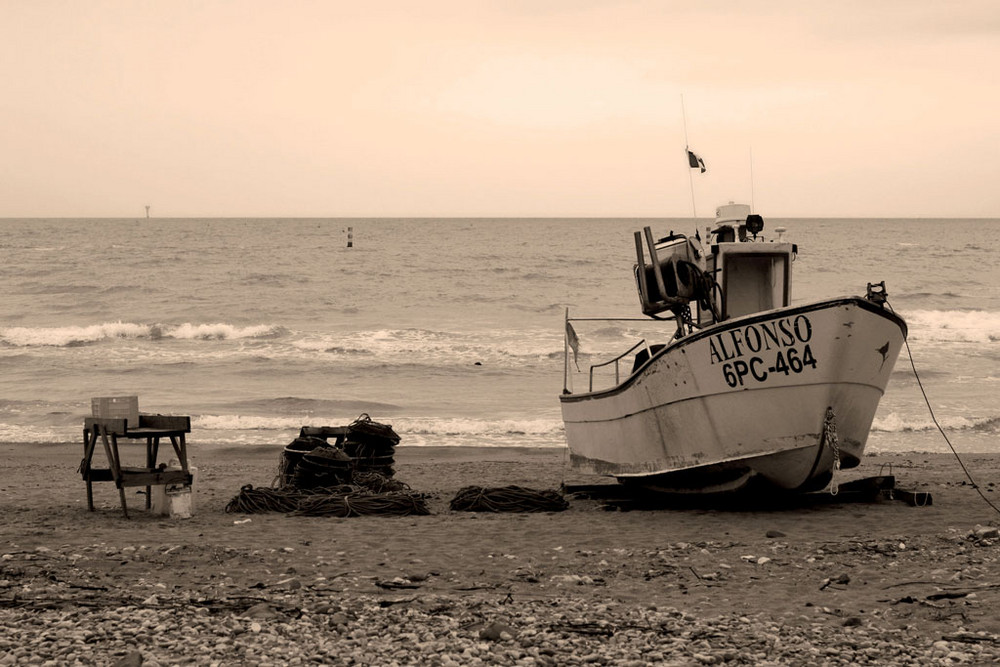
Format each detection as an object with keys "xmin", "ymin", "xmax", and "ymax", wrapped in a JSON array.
[{"xmin": 0, "ymin": 0, "xmax": 1000, "ymax": 217}]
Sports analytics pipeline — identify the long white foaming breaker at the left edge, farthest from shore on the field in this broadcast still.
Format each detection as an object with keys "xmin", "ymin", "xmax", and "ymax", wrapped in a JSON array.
[{"xmin": 0, "ymin": 321, "xmax": 285, "ymax": 347}]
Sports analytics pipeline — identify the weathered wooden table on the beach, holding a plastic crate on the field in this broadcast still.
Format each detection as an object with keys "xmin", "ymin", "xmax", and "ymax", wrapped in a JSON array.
[{"xmin": 80, "ymin": 415, "xmax": 193, "ymax": 519}]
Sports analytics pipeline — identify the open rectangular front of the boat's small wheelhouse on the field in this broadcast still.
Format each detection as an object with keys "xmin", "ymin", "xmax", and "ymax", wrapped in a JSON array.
[{"xmin": 723, "ymin": 253, "xmax": 789, "ymax": 318}]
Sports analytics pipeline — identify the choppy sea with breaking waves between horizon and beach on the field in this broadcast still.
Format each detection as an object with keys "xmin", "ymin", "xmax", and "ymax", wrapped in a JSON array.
[{"xmin": 0, "ymin": 216, "xmax": 1000, "ymax": 452}]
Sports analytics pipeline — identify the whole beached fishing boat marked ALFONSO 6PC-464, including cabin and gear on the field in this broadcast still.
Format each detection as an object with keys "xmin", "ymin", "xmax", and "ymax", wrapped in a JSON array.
[{"xmin": 560, "ymin": 203, "xmax": 906, "ymax": 493}]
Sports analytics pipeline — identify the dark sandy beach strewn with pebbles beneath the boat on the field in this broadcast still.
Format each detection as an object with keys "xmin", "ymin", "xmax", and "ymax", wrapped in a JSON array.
[{"xmin": 0, "ymin": 441, "xmax": 1000, "ymax": 665}]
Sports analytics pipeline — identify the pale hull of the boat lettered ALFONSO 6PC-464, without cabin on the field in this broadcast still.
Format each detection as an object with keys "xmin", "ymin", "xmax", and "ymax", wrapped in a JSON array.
[{"xmin": 561, "ymin": 297, "xmax": 906, "ymax": 492}]
